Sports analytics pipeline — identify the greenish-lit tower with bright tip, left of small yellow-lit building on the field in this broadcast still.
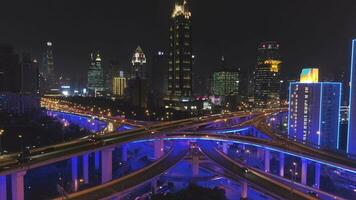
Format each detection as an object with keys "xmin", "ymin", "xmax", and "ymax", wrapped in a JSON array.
[{"xmin": 88, "ymin": 53, "xmax": 104, "ymax": 96}]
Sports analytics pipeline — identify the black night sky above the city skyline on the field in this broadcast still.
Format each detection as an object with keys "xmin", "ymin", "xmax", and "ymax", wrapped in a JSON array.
[{"xmin": 0, "ymin": 0, "xmax": 356, "ymax": 78}]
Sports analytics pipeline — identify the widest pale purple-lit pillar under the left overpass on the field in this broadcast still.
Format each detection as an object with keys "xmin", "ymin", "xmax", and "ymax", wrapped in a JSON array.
[{"xmin": 101, "ymin": 148, "xmax": 114, "ymax": 183}]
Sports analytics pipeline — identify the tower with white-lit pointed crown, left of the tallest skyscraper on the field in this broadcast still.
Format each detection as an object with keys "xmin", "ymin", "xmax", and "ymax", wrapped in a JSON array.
[{"xmin": 131, "ymin": 46, "xmax": 147, "ymax": 79}]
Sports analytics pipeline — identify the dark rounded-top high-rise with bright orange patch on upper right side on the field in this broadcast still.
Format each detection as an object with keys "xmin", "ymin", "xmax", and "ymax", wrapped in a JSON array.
[{"xmin": 254, "ymin": 42, "xmax": 282, "ymax": 107}]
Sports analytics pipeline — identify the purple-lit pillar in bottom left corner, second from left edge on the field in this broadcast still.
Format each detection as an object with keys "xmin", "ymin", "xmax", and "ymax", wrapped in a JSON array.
[{"xmin": 11, "ymin": 171, "xmax": 26, "ymax": 200}]
